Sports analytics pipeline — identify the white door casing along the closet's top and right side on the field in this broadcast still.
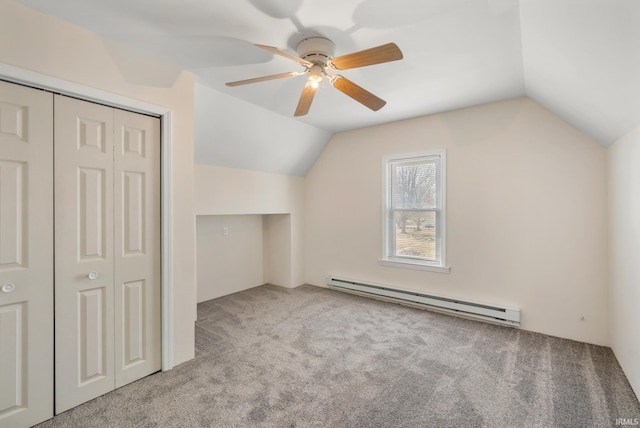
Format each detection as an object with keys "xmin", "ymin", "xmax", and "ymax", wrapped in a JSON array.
[{"xmin": 0, "ymin": 63, "xmax": 173, "ymax": 370}]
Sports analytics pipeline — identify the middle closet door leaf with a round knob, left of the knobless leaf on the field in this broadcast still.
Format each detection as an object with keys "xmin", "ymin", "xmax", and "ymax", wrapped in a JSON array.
[{"xmin": 54, "ymin": 95, "xmax": 115, "ymax": 413}]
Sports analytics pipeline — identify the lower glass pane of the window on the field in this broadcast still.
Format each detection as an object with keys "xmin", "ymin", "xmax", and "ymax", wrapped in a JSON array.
[{"xmin": 393, "ymin": 211, "xmax": 438, "ymax": 260}]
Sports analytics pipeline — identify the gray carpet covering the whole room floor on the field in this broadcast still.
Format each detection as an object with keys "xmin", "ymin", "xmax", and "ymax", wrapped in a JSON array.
[{"xmin": 39, "ymin": 285, "xmax": 640, "ymax": 428}]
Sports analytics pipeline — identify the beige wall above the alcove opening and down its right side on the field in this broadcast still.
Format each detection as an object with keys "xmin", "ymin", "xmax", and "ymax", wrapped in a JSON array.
[{"xmin": 195, "ymin": 165, "xmax": 304, "ymax": 287}]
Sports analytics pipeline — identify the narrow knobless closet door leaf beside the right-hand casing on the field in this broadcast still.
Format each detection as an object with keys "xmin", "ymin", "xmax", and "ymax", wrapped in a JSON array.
[{"xmin": 114, "ymin": 110, "xmax": 162, "ymax": 388}]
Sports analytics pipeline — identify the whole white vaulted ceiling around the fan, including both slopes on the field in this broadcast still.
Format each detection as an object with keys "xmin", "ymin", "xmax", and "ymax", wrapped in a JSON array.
[{"xmin": 20, "ymin": 0, "xmax": 640, "ymax": 175}]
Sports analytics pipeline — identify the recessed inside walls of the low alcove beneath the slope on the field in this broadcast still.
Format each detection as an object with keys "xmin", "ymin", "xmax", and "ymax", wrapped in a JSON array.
[{"xmin": 196, "ymin": 214, "xmax": 292, "ymax": 302}]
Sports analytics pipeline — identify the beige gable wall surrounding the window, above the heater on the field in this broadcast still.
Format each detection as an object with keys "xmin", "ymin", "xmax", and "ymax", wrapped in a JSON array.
[{"xmin": 305, "ymin": 98, "xmax": 608, "ymax": 344}]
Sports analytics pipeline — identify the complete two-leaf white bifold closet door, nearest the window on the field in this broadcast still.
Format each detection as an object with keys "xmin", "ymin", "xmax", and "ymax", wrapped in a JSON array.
[{"xmin": 54, "ymin": 95, "xmax": 161, "ymax": 413}]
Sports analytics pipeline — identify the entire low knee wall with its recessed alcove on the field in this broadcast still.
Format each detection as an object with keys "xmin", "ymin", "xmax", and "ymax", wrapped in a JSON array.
[{"xmin": 194, "ymin": 164, "xmax": 305, "ymax": 302}]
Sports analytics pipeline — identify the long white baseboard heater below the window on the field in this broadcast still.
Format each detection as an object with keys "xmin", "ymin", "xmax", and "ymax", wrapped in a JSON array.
[{"xmin": 327, "ymin": 276, "xmax": 520, "ymax": 327}]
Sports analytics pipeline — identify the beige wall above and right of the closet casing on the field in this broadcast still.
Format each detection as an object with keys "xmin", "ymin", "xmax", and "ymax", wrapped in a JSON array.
[{"xmin": 0, "ymin": 0, "xmax": 196, "ymax": 364}]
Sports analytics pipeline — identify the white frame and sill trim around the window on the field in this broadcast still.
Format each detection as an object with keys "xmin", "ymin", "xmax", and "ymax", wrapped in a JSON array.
[{"xmin": 379, "ymin": 149, "xmax": 450, "ymax": 273}]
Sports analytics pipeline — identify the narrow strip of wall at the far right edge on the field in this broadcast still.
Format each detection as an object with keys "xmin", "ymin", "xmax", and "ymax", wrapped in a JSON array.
[{"xmin": 608, "ymin": 127, "xmax": 640, "ymax": 396}]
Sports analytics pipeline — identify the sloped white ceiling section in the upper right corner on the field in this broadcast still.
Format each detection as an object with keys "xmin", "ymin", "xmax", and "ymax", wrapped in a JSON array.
[{"xmin": 520, "ymin": 0, "xmax": 640, "ymax": 145}]
